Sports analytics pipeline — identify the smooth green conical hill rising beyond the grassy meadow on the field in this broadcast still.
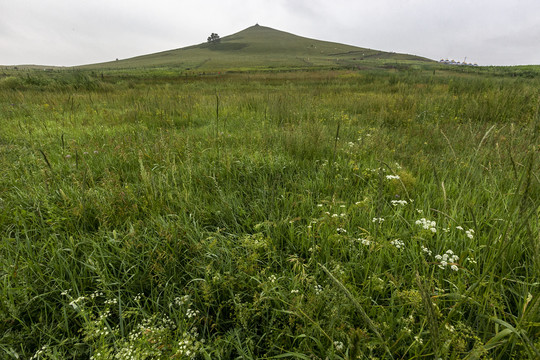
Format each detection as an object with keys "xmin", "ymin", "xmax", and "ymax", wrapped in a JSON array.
[{"xmin": 83, "ymin": 25, "xmax": 431, "ymax": 71}]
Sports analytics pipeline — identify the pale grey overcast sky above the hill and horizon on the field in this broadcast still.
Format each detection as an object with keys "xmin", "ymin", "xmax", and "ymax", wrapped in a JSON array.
[{"xmin": 0, "ymin": 0, "xmax": 540, "ymax": 66}]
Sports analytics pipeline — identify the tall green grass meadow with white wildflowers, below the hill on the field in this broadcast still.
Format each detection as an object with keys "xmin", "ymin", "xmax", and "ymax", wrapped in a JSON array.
[{"xmin": 0, "ymin": 64, "xmax": 540, "ymax": 360}]
